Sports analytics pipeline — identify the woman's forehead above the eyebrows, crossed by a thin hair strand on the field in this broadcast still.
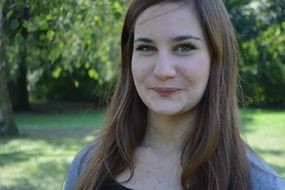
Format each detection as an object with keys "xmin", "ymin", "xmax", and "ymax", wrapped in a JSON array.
[{"xmin": 134, "ymin": 3, "xmax": 203, "ymax": 38}]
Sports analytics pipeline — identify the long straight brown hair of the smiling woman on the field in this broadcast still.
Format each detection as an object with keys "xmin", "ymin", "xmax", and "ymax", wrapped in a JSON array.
[{"xmin": 76, "ymin": 0, "xmax": 251, "ymax": 190}]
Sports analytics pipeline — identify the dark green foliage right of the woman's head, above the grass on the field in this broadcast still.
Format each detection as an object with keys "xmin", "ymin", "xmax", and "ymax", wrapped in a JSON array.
[{"xmin": 226, "ymin": 0, "xmax": 285, "ymax": 107}]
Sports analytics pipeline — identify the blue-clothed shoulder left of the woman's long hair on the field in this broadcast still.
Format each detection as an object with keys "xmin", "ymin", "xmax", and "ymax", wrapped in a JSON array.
[{"xmin": 64, "ymin": 140, "xmax": 100, "ymax": 190}]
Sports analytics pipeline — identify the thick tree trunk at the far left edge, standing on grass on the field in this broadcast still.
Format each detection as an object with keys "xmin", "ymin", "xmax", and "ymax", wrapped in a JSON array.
[{"xmin": 0, "ymin": 3, "xmax": 18, "ymax": 136}]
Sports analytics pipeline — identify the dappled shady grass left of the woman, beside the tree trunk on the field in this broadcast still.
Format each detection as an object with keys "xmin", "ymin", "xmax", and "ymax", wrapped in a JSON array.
[{"xmin": 0, "ymin": 112, "xmax": 104, "ymax": 190}]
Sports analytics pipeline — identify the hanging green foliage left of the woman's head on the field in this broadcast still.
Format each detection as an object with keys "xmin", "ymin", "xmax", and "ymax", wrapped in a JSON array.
[{"xmin": 5, "ymin": 0, "xmax": 126, "ymax": 102}]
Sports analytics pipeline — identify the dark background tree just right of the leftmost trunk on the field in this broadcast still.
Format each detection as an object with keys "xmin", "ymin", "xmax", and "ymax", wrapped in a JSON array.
[{"xmin": 3, "ymin": 0, "xmax": 30, "ymax": 111}]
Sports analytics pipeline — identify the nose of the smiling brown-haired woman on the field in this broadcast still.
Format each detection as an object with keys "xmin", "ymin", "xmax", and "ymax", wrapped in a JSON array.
[{"xmin": 153, "ymin": 53, "xmax": 176, "ymax": 81}]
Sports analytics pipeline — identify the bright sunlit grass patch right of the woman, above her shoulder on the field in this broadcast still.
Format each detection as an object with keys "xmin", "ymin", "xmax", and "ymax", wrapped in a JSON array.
[{"xmin": 242, "ymin": 110, "xmax": 285, "ymax": 178}]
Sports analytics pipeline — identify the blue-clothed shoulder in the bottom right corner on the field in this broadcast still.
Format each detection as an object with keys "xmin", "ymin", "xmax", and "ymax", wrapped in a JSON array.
[{"xmin": 247, "ymin": 151, "xmax": 285, "ymax": 190}]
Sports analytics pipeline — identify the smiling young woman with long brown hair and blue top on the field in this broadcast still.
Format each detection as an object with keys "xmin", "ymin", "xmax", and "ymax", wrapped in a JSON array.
[{"xmin": 65, "ymin": 0, "xmax": 285, "ymax": 190}]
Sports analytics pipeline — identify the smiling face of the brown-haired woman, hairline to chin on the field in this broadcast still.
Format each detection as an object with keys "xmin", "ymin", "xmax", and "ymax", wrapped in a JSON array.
[{"xmin": 132, "ymin": 3, "xmax": 211, "ymax": 116}]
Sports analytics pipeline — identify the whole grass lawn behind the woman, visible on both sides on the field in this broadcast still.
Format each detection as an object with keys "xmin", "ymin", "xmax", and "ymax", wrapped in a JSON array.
[{"xmin": 0, "ymin": 109, "xmax": 285, "ymax": 190}]
